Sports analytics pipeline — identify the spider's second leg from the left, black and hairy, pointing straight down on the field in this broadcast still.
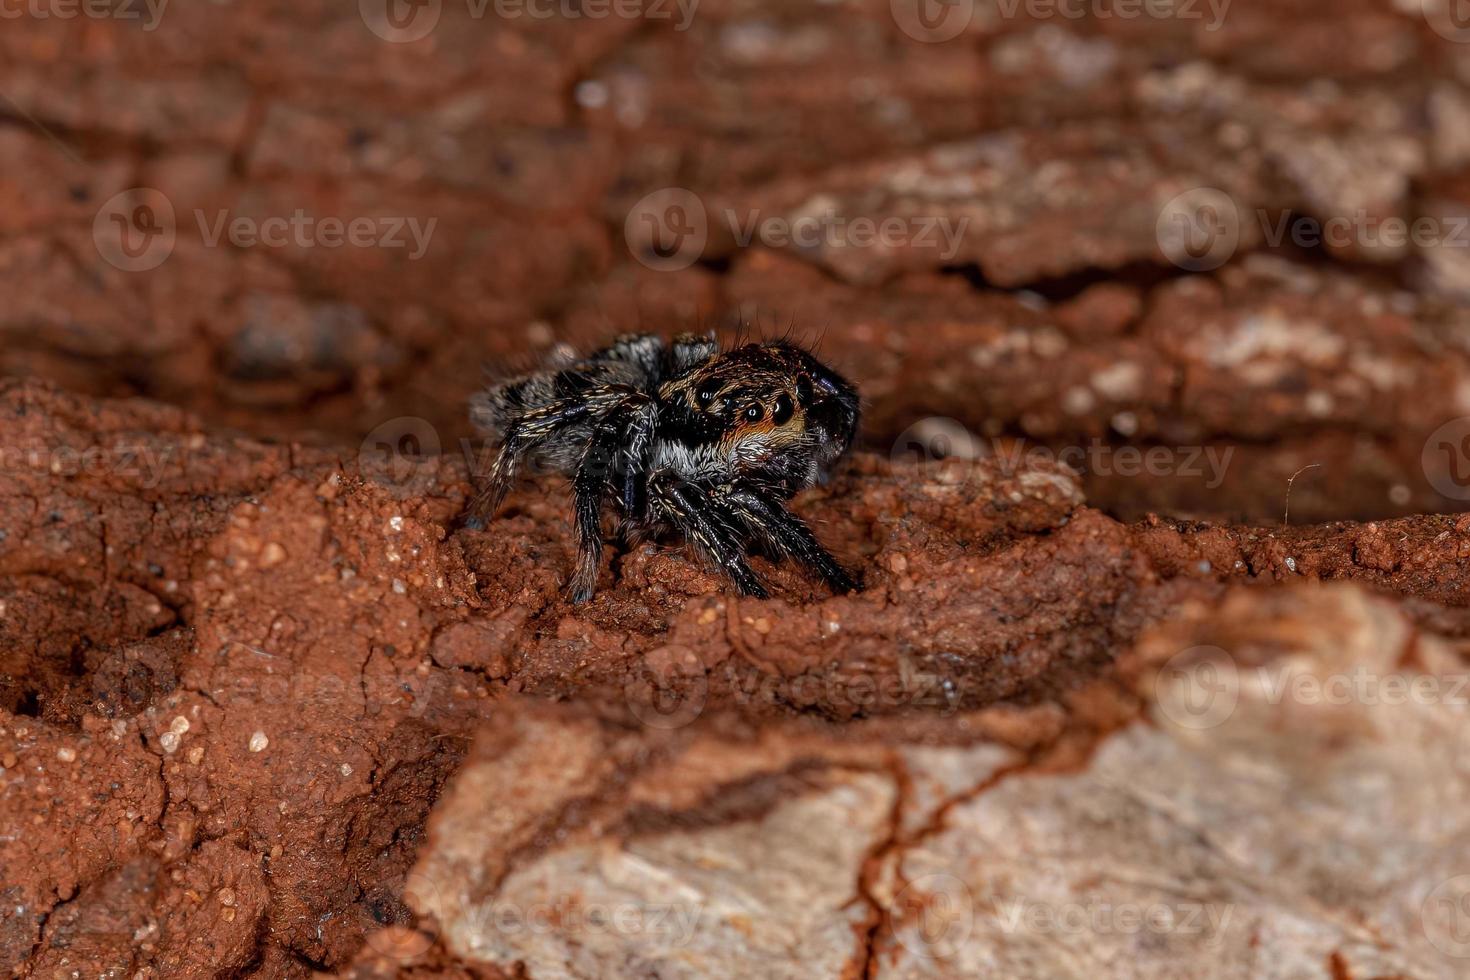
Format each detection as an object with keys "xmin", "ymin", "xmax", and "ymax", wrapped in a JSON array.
[{"xmin": 567, "ymin": 394, "xmax": 659, "ymax": 602}]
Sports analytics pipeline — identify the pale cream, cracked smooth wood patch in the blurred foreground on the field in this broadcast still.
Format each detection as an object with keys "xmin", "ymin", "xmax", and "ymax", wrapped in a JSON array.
[{"xmin": 409, "ymin": 588, "xmax": 1470, "ymax": 977}]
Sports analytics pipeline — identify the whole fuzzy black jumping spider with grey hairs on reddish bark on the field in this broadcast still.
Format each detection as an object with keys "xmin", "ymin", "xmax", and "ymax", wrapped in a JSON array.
[{"xmin": 470, "ymin": 335, "xmax": 858, "ymax": 602}]
